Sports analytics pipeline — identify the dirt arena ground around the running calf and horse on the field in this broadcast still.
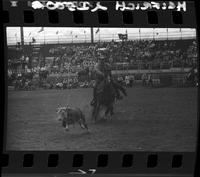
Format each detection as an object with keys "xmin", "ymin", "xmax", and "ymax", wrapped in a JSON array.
[{"xmin": 6, "ymin": 87, "xmax": 197, "ymax": 151}]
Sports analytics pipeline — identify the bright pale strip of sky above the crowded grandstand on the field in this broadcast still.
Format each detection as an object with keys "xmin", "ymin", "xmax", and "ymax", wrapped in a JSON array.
[{"xmin": 7, "ymin": 27, "xmax": 196, "ymax": 45}]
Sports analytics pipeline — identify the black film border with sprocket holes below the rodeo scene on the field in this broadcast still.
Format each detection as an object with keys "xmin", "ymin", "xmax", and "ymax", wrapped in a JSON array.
[{"xmin": 2, "ymin": 152, "xmax": 195, "ymax": 174}]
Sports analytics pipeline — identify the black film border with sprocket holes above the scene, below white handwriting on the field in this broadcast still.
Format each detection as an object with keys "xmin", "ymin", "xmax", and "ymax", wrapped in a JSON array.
[{"xmin": 3, "ymin": 0, "xmax": 196, "ymax": 28}]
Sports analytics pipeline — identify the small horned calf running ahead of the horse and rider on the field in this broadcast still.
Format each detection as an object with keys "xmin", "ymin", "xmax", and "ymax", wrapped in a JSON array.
[{"xmin": 57, "ymin": 107, "xmax": 88, "ymax": 131}]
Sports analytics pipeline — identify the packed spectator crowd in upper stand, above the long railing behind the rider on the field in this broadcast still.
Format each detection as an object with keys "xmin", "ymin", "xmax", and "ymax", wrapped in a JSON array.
[{"xmin": 44, "ymin": 40, "xmax": 197, "ymax": 71}]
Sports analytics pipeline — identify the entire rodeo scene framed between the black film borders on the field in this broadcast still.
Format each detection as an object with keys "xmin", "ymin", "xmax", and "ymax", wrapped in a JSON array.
[{"xmin": 6, "ymin": 27, "xmax": 198, "ymax": 151}]
